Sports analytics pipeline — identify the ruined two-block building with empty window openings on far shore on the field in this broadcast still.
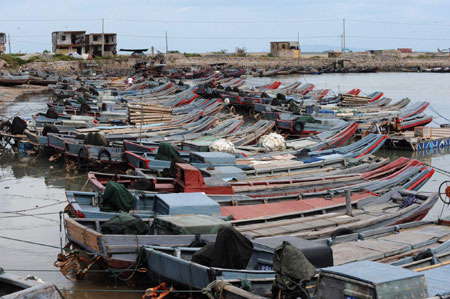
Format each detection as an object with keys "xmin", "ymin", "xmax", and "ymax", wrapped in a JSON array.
[{"xmin": 52, "ymin": 31, "xmax": 117, "ymax": 56}]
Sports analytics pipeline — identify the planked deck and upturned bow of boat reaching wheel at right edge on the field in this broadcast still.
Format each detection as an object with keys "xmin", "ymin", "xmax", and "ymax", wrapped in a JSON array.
[{"xmin": 234, "ymin": 188, "xmax": 438, "ymax": 239}]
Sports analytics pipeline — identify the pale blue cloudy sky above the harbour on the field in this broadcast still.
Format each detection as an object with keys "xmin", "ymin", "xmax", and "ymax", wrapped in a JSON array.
[{"xmin": 0, "ymin": 0, "xmax": 450, "ymax": 52}]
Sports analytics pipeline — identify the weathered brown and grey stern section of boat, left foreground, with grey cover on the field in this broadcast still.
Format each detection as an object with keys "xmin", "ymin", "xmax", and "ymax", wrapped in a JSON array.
[{"xmin": 64, "ymin": 215, "xmax": 226, "ymax": 275}]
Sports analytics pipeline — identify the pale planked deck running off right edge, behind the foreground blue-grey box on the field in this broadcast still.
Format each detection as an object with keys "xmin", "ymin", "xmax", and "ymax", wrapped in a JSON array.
[{"xmin": 314, "ymin": 221, "xmax": 450, "ymax": 269}]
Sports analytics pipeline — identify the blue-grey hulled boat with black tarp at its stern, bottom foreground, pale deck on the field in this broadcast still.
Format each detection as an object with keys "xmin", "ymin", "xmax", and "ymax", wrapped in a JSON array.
[{"xmin": 144, "ymin": 216, "xmax": 450, "ymax": 295}]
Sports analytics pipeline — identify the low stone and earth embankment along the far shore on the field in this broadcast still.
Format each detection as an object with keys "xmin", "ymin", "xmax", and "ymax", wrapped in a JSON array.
[{"xmin": 9, "ymin": 53, "xmax": 450, "ymax": 74}]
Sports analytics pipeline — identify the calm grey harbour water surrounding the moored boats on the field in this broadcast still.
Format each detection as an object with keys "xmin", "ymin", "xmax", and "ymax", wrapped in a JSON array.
[{"xmin": 0, "ymin": 73, "xmax": 450, "ymax": 298}]
